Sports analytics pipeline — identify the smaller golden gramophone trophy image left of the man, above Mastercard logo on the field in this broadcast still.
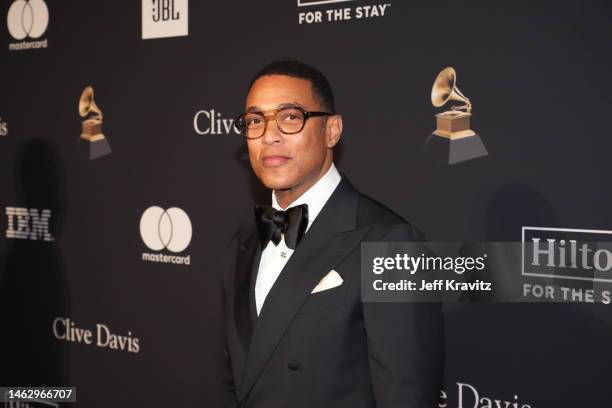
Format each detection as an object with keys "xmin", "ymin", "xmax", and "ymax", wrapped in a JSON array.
[{"xmin": 79, "ymin": 86, "xmax": 111, "ymax": 160}]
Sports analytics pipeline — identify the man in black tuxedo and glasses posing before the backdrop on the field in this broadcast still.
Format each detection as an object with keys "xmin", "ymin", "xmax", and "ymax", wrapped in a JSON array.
[{"xmin": 224, "ymin": 61, "xmax": 443, "ymax": 408}]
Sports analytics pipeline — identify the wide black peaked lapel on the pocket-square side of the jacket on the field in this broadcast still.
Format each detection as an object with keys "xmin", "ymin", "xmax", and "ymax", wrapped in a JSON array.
[{"xmin": 239, "ymin": 178, "xmax": 367, "ymax": 400}]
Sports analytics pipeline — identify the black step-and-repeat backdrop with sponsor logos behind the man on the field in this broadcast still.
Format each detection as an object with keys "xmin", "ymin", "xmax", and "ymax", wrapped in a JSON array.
[{"xmin": 0, "ymin": 0, "xmax": 612, "ymax": 408}]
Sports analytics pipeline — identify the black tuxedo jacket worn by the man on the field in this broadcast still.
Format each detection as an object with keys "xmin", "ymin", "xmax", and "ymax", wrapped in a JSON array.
[{"xmin": 224, "ymin": 176, "xmax": 444, "ymax": 408}]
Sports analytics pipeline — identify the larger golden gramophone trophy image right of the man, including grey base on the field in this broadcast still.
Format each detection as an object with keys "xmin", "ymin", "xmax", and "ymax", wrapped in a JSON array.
[{"xmin": 423, "ymin": 67, "xmax": 487, "ymax": 164}]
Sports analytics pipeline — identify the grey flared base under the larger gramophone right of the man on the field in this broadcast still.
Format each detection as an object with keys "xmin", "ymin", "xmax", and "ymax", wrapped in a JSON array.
[{"xmin": 423, "ymin": 132, "xmax": 488, "ymax": 165}]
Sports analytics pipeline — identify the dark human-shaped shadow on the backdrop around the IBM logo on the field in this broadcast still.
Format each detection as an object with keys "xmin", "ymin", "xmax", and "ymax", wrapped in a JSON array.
[{"xmin": 0, "ymin": 139, "xmax": 70, "ymax": 386}]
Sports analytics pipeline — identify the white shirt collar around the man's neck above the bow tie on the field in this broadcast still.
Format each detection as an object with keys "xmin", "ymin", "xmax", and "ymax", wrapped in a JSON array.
[{"xmin": 272, "ymin": 163, "xmax": 342, "ymax": 231}]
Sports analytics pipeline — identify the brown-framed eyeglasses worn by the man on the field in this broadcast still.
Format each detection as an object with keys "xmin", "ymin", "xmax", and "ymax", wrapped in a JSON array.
[{"xmin": 234, "ymin": 106, "xmax": 333, "ymax": 139}]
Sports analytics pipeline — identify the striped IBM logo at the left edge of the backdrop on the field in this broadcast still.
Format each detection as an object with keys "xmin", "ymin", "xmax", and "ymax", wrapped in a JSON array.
[{"xmin": 6, "ymin": 207, "xmax": 55, "ymax": 242}]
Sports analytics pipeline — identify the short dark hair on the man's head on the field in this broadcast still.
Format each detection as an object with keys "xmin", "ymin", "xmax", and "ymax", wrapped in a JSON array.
[{"xmin": 249, "ymin": 61, "xmax": 336, "ymax": 113}]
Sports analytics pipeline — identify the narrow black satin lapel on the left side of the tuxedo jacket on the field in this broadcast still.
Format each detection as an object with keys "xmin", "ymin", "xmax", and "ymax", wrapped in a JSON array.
[{"xmin": 234, "ymin": 231, "xmax": 261, "ymax": 353}]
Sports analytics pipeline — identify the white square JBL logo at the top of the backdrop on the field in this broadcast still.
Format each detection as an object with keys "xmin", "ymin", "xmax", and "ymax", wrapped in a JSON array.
[{"xmin": 142, "ymin": 0, "xmax": 189, "ymax": 39}]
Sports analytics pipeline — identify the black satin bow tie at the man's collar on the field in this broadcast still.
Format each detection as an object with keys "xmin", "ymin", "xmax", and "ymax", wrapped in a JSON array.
[{"xmin": 255, "ymin": 204, "xmax": 308, "ymax": 249}]
